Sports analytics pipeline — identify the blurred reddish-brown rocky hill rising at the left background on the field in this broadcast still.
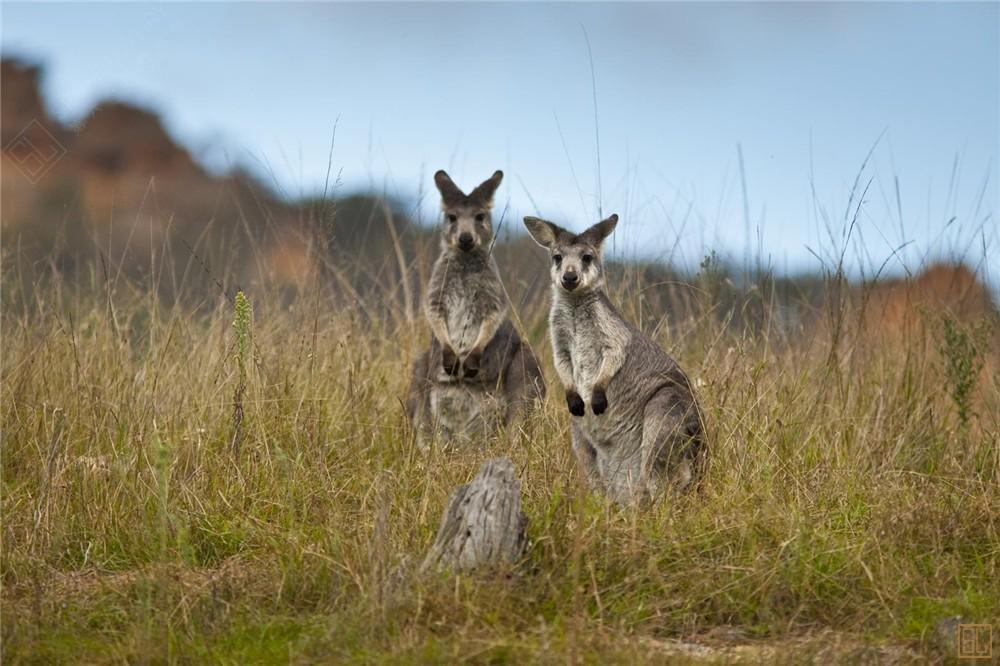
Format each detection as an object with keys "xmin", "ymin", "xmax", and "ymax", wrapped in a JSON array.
[{"xmin": 0, "ymin": 59, "xmax": 324, "ymax": 291}]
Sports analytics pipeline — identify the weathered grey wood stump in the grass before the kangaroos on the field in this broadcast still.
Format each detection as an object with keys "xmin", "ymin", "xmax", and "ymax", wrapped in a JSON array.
[{"xmin": 421, "ymin": 458, "xmax": 528, "ymax": 571}]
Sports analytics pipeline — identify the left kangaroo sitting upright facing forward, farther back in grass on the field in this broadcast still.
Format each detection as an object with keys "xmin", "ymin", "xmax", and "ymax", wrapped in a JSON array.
[{"xmin": 406, "ymin": 171, "xmax": 545, "ymax": 449}]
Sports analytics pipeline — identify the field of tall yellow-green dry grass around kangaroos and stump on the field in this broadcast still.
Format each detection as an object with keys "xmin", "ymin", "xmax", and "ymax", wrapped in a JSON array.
[{"xmin": 0, "ymin": 243, "xmax": 1000, "ymax": 664}]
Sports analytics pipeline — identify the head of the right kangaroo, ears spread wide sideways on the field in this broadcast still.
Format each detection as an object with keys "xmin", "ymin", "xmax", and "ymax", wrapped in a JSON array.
[{"xmin": 524, "ymin": 215, "xmax": 618, "ymax": 294}]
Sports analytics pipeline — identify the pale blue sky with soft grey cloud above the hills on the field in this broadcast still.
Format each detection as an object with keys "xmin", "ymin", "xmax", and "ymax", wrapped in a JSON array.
[{"xmin": 2, "ymin": 3, "xmax": 1000, "ymax": 283}]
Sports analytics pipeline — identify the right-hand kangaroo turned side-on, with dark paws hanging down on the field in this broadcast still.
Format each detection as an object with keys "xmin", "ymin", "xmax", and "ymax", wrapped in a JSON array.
[{"xmin": 524, "ymin": 215, "xmax": 707, "ymax": 505}]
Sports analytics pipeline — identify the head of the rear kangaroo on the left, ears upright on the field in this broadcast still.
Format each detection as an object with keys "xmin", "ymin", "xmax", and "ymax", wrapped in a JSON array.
[{"xmin": 434, "ymin": 170, "xmax": 503, "ymax": 252}]
